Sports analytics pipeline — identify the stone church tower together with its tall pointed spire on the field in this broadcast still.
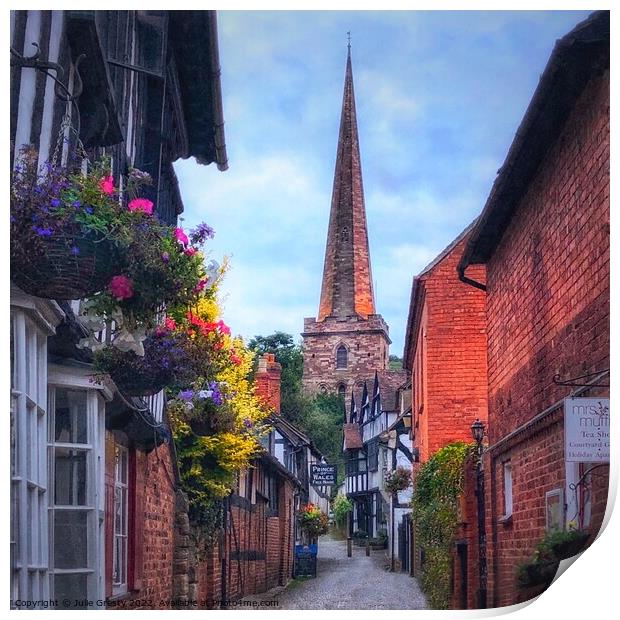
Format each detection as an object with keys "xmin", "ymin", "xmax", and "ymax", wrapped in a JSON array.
[{"xmin": 302, "ymin": 46, "xmax": 391, "ymax": 395}]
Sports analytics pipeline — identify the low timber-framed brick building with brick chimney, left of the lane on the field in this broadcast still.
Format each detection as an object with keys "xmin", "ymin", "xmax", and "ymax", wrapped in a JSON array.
[{"xmin": 194, "ymin": 354, "xmax": 302, "ymax": 607}]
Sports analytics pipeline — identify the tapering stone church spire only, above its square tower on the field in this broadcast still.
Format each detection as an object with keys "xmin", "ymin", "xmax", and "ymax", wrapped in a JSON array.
[{"xmin": 317, "ymin": 46, "xmax": 375, "ymax": 321}]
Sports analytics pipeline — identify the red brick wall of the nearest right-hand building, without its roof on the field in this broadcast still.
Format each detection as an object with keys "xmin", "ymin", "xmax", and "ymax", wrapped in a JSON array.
[{"xmin": 482, "ymin": 72, "xmax": 609, "ymax": 606}]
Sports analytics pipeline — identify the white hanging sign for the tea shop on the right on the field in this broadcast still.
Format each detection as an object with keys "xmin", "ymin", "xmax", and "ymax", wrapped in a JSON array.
[{"xmin": 564, "ymin": 398, "xmax": 609, "ymax": 463}]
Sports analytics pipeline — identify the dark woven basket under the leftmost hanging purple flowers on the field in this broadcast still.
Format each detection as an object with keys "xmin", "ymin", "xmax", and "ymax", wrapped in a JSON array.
[{"xmin": 11, "ymin": 225, "xmax": 118, "ymax": 300}]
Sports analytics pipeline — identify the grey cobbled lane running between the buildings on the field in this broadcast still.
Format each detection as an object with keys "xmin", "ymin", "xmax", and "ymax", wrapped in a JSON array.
[{"xmin": 244, "ymin": 536, "xmax": 427, "ymax": 610}]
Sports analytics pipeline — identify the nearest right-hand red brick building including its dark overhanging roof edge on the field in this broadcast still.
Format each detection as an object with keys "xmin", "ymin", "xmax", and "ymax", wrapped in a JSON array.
[{"xmin": 458, "ymin": 12, "xmax": 609, "ymax": 607}]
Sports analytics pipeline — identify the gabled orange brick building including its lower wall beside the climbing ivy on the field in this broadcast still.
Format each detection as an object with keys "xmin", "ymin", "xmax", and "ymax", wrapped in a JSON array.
[{"xmin": 403, "ymin": 224, "xmax": 488, "ymax": 609}]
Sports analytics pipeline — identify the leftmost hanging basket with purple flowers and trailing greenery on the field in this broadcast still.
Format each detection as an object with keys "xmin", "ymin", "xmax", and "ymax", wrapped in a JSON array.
[{"xmin": 10, "ymin": 147, "xmax": 125, "ymax": 299}]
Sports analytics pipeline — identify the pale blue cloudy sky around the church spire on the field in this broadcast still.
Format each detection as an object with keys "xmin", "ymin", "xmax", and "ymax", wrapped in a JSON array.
[{"xmin": 175, "ymin": 11, "xmax": 588, "ymax": 356}]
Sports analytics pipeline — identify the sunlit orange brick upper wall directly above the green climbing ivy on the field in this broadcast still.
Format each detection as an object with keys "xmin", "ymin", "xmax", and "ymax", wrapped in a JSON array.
[{"xmin": 407, "ymin": 235, "xmax": 487, "ymax": 462}]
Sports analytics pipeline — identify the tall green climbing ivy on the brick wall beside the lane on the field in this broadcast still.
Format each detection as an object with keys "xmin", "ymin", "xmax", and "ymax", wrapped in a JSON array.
[{"xmin": 412, "ymin": 442, "xmax": 474, "ymax": 609}]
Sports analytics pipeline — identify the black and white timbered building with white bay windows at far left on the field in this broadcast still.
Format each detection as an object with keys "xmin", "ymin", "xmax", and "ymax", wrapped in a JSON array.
[{"xmin": 10, "ymin": 10, "xmax": 227, "ymax": 601}]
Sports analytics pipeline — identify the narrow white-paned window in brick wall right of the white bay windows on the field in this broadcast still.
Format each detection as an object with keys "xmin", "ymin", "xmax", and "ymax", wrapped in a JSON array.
[{"xmin": 112, "ymin": 444, "xmax": 129, "ymax": 595}]
